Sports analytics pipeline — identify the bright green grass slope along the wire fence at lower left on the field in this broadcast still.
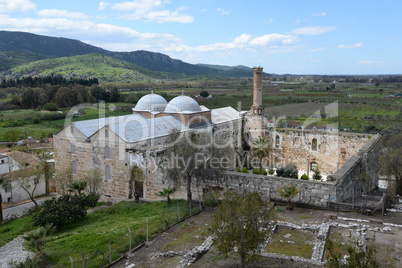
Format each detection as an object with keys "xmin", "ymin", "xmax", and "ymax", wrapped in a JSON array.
[{"xmin": 0, "ymin": 200, "xmax": 197, "ymax": 267}]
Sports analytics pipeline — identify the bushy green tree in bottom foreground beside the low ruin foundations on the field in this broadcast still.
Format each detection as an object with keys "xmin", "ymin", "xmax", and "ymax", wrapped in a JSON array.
[{"xmin": 211, "ymin": 191, "xmax": 273, "ymax": 268}]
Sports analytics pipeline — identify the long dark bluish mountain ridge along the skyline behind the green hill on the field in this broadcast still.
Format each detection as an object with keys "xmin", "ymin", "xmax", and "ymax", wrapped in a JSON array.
[{"xmin": 0, "ymin": 31, "xmax": 262, "ymax": 77}]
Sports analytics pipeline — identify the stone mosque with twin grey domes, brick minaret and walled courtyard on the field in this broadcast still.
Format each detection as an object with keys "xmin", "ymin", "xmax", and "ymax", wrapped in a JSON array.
[{"xmin": 53, "ymin": 67, "xmax": 372, "ymax": 200}]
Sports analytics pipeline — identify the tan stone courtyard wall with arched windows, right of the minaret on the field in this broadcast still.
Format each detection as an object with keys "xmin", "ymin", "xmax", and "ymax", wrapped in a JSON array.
[{"xmin": 270, "ymin": 129, "xmax": 372, "ymax": 178}]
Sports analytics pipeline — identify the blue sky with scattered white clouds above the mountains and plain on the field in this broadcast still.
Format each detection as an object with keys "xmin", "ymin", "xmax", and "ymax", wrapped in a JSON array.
[{"xmin": 0, "ymin": 0, "xmax": 402, "ymax": 74}]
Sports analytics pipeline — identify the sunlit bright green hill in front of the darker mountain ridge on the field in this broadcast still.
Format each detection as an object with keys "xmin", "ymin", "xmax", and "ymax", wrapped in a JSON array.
[{"xmin": 8, "ymin": 53, "xmax": 168, "ymax": 82}]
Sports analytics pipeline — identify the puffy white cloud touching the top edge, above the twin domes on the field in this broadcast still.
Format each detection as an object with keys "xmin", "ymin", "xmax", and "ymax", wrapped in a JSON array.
[{"xmin": 111, "ymin": 0, "xmax": 194, "ymax": 23}]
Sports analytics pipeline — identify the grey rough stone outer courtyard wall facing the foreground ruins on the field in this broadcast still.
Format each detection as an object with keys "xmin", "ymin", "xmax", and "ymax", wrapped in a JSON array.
[{"xmin": 197, "ymin": 172, "xmax": 336, "ymax": 207}]
